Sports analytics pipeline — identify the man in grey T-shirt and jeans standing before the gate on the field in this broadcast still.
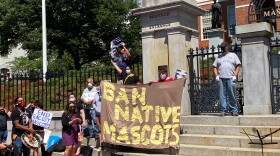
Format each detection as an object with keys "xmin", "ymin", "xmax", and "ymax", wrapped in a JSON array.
[{"xmin": 213, "ymin": 42, "xmax": 241, "ymax": 116}]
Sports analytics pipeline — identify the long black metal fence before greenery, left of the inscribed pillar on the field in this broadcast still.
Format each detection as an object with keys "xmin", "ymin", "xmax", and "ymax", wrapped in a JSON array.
[{"xmin": 0, "ymin": 58, "xmax": 143, "ymax": 110}]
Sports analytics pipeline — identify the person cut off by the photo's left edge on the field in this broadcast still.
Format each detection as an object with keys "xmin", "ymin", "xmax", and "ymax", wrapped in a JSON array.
[{"xmin": 0, "ymin": 106, "xmax": 9, "ymax": 156}]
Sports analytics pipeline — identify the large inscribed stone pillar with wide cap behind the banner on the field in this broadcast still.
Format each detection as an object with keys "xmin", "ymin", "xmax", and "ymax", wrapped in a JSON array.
[{"xmin": 132, "ymin": 0, "xmax": 204, "ymax": 115}]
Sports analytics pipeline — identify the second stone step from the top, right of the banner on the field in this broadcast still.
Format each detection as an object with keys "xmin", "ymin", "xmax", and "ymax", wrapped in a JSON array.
[{"xmin": 180, "ymin": 124, "xmax": 280, "ymax": 137}]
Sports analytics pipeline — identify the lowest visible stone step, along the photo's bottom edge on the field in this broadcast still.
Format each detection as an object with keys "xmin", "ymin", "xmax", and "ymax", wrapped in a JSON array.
[{"xmin": 179, "ymin": 144, "xmax": 280, "ymax": 156}]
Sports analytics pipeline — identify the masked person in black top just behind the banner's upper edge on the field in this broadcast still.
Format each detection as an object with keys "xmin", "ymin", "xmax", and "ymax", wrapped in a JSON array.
[{"xmin": 111, "ymin": 60, "xmax": 140, "ymax": 85}]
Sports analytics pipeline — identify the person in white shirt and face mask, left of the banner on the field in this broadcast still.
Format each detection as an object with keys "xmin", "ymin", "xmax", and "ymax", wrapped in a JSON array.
[{"xmin": 81, "ymin": 78, "xmax": 99, "ymax": 142}]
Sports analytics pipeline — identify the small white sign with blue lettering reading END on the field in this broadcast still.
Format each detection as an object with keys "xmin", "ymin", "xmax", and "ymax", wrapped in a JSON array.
[{"xmin": 32, "ymin": 109, "xmax": 53, "ymax": 128}]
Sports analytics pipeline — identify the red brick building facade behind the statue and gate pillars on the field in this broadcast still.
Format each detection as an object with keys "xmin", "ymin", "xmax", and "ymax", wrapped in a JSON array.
[{"xmin": 197, "ymin": 0, "xmax": 280, "ymax": 47}]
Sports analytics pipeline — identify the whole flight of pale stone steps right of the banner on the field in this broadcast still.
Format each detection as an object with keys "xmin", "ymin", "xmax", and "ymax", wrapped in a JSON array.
[{"xmin": 179, "ymin": 115, "xmax": 280, "ymax": 156}]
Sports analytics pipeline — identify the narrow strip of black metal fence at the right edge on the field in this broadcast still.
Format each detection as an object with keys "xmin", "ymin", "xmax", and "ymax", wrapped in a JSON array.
[{"xmin": 269, "ymin": 38, "xmax": 280, "ymax": 114}]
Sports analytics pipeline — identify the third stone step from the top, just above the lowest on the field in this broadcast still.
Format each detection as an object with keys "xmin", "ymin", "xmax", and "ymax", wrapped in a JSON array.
[{"xmin": 180, "ymin": 134, "xmax": 280, "ymax": 149}]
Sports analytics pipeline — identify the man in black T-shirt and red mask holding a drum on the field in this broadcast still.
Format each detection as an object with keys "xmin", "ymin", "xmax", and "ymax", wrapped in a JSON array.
[{"xmin": 11, "ymin": 97, "xmax": 34, "ymax": 156}]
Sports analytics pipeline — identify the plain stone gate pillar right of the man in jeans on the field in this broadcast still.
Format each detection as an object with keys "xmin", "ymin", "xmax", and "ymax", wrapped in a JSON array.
[{"xmin": 236, "ymin": 22, "xmax": 272, "ymax": 115}]
